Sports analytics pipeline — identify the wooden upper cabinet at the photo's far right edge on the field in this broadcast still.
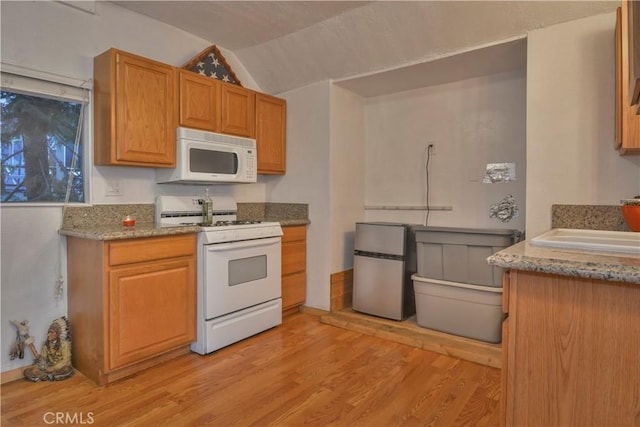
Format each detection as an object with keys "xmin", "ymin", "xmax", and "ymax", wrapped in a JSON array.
[{"xmin": 615, "ymin": 2, "xmax": 640, "ymax": 154}]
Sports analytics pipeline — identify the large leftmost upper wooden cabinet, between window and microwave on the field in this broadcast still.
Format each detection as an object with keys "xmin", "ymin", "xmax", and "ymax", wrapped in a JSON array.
[{"xmin": 93, "ymin": 49, "xmax": 177, "ymax": 167}]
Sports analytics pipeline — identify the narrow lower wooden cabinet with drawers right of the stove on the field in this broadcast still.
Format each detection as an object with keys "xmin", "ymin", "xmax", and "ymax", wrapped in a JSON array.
[{"xmin": 282, "ymin": 225, "xmax": 307, "ymax": 312}]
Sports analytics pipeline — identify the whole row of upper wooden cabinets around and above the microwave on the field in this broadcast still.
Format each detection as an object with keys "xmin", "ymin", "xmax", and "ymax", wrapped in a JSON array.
[{"xmin": 94, "ymin": 49, "xmax": 287, "ymax": 174}]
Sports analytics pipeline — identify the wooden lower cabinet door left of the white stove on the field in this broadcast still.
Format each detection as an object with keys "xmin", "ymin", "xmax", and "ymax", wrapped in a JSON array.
[{"xmin": 108, "ymin": 258, "xmax": 196, "ymax": 370}]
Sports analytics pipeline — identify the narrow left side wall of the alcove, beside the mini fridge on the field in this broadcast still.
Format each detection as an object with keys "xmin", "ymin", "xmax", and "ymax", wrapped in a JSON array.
[{"xmin": 330, "ymin": 85, "xmax": 365, "ymax": 273}]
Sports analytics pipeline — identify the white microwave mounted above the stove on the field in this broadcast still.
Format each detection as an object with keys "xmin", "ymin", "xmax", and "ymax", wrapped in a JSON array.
[{"xmin": 156, "ymin": 127, "xmax": 258, "ymax": 184}]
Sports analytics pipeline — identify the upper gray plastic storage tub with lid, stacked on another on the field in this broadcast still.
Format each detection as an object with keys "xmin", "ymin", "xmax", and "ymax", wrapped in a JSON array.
[{"xmin": 415, "ymin": 226, "xmax": 521, "ymax": 287}]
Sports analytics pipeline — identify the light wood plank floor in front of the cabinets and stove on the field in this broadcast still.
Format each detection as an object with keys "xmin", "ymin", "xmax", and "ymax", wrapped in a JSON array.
[{"xmin": 1, "ymin": 313, "xmax": 500, "ymax": 426}]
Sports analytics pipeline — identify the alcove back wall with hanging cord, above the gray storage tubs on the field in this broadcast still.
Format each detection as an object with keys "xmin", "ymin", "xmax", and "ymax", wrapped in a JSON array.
[{"xmin": 365, "ymin": 70, "xmax": 526, "ymax": 230}]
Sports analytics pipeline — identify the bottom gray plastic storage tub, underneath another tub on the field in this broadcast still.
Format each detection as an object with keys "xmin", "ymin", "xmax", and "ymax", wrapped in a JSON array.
[{"xmin": 411, "ymin": 274, "xmax": 504, "ymax": 343}]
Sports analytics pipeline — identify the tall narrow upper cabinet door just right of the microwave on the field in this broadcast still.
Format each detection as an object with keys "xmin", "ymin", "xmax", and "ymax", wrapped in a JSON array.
[{"xmin": 256, "ymin": 93, "xmax": 287, "ymax": 175}]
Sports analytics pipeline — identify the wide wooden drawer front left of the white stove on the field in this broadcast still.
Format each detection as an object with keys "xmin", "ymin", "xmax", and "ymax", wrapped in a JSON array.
[{"xmin": 108, "ymin": 234, "xmax": 196, "ymax": 266}]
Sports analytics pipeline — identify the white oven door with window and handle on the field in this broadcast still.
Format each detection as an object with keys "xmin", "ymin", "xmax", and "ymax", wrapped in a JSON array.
[{"xmin": 203, "ymin": 237, "xmax": 282, "ymax": 320}]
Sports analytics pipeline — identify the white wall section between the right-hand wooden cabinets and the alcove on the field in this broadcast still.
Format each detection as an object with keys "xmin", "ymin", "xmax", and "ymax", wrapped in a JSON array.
[{"xmin": 267, "ymin": 82, "xmax": 332, "ymax": 310}]
